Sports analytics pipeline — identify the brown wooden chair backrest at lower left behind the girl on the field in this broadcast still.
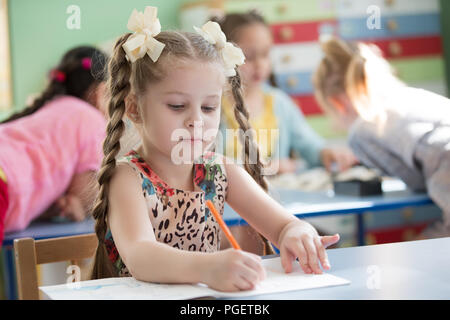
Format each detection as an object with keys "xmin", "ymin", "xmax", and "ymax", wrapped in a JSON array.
[{"xmin": 14, "ymin": 233, "xmax": 98, "ymax": 300}]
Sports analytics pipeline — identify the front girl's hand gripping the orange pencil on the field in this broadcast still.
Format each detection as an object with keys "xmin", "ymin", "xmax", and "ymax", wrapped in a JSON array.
[{"xmin": 205, "ymin": 248, "xmax": 266, "ymax": 291}]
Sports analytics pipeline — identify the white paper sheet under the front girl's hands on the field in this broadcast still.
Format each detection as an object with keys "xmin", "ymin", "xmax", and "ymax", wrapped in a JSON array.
[{"xmin": 39, "ymin": 257, "xmax": 350, "ymax": 300}]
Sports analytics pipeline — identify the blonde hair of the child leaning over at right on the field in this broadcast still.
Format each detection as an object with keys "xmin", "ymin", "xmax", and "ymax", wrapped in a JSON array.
[{"xmin": 313, "ymin": 37, "xmax": 401, "ymax": 121}]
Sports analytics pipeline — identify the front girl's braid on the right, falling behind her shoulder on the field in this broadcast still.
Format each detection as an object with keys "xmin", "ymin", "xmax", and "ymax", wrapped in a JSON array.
[{"xmin": 229, "ymin": 70, "xmax": 275, "ymax": 255}]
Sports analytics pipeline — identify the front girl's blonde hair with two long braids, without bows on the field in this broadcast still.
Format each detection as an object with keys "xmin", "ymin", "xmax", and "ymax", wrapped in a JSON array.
[{"xmin": 91, "ymin": 31, "xmax": 273, "ymax": 279}]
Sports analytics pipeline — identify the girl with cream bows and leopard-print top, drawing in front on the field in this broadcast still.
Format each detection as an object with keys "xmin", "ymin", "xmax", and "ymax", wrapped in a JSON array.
[{"xmin": 93, "ymin": 7, "xmax": 339, "ymax": 291}]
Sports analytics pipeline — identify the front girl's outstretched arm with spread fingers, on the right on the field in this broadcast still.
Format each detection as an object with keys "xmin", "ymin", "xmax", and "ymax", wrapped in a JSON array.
[{"xmin": 225, "ymin": 163, "xmax": 339, "ymax": 273}]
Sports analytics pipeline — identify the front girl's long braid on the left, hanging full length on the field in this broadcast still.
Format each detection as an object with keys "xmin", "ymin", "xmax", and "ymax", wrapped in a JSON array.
[{"xmin": 92, "ymin": 33, "xmax": 131, "ymax": 279}]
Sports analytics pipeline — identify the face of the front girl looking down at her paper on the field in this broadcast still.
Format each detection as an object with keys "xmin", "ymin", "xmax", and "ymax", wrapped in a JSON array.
[{"xmin": 132, "ymin": 60, "xmax": 225, "ymax": 163}]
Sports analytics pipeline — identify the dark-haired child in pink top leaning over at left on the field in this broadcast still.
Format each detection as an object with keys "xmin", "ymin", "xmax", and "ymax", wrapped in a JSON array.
[{"xmin": 0, "ymin": 46, "xmax": 106, "ymax": 243}]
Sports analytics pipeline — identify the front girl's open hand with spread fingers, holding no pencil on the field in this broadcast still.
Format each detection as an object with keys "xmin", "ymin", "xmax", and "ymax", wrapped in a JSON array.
[{"xmin": 278, "ymin": 220, "xmax": 339, "ymax": 274}]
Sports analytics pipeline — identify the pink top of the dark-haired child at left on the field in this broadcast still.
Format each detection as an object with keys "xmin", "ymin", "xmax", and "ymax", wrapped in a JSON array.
[{"xmin": 0, "ymin": 96, "xmax": 106, "ymax": 232}]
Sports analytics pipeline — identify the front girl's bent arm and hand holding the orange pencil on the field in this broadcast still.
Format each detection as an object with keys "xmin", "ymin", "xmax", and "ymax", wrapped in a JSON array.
[{"xmin": 108, "ymin": 165, "xmax": 264, "ymax": 291}]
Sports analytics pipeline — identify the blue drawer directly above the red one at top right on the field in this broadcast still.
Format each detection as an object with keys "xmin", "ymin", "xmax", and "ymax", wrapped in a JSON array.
[{"xmin": 338, "ymin": 14, "xmax": 441, "ymax": 40}]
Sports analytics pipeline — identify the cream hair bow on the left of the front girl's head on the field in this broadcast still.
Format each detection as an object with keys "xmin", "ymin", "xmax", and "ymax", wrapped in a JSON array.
[{"xmin": 122, "ymin": 6, "xmax": 165, "ymax": 62}]
